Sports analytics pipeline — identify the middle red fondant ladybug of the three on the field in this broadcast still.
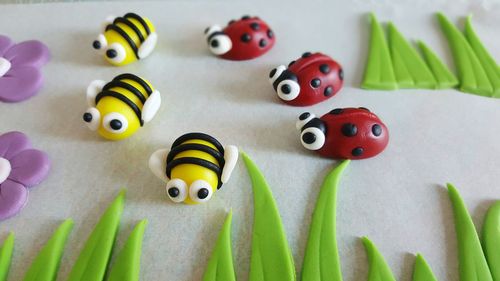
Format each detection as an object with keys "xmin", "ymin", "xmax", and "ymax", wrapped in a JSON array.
[{"xmin": 269, "ymin": 52, "xmax": 344, "ymax": 106}]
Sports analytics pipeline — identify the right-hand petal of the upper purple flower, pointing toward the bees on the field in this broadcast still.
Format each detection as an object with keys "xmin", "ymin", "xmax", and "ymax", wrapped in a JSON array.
[{"xmin": 3, "ymin": 40, "xmax": 50, "ymax": 67}]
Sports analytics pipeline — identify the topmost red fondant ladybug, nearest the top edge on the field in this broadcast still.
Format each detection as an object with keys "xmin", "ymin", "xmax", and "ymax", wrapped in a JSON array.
[{"xmin": 205, "ymin": 16, "xmax": 276, "ymax": 60}]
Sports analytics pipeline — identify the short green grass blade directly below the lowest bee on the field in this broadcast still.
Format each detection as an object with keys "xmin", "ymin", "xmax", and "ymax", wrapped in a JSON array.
[{"xmin": 203, "ymin": 212, "xmax": 236, "ymax": 281}]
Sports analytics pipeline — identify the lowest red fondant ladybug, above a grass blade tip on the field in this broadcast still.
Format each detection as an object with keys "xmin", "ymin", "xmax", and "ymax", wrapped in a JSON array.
[{"xmin": 296, "ymin": 107, "xmax": 389, "ymax": 159}]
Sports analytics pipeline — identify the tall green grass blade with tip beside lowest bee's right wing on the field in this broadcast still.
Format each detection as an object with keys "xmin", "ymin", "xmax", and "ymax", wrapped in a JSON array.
[{"xmin": 242, "ymin": 153, "xmax": 296, "ymax": 281}]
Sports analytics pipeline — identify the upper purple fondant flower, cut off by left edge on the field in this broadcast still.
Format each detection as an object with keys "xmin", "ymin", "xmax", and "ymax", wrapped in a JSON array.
[{"xmin": 0, "ymin": 35, "xmax": 50, "ymax": 102}]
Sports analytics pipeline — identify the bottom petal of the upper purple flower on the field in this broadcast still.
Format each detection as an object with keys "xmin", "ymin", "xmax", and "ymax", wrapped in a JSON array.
[{"xmin": 0, "ymin": 65, "xmax": 43, "ymax": 102}]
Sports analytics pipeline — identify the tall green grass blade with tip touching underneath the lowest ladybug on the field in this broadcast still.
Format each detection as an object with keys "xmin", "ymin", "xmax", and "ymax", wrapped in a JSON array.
[{"xmin": 301, "ymin": 160, "xmax": 349, "ymax": 281}]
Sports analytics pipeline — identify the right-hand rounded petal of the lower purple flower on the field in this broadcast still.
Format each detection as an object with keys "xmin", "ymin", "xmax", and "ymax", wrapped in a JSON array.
[{"xmin": 9, "ymin": 149, "xmax": 50, "ymax": 187}]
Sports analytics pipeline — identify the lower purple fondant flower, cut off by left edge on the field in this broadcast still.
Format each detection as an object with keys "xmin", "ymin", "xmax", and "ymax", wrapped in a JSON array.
[{"xmin": 0, "ymin": 132, "xmax": 50, "ymax": 220}]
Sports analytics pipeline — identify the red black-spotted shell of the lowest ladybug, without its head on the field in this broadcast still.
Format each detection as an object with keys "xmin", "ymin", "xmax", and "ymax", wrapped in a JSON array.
[{"xmin": 318, "ymin": 108, "xmax": 389, "ymax": 159}]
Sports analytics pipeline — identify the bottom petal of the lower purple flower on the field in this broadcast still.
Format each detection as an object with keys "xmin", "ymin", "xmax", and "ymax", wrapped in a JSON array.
[{"xmin": 0, "ymin": 180, "xmax": 28, "ymax": 220}]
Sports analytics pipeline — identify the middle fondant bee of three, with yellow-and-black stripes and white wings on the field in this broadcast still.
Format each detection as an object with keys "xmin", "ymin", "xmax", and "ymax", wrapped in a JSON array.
[{"xmin": 83, "ymin": 73, "xmax": 161, "ymax": 140}]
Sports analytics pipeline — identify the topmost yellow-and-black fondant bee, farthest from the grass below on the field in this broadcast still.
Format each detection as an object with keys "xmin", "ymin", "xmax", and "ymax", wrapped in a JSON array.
[{"xmin": 92, "ymin": 13, "xmax": 158, "ymax": 66}]
